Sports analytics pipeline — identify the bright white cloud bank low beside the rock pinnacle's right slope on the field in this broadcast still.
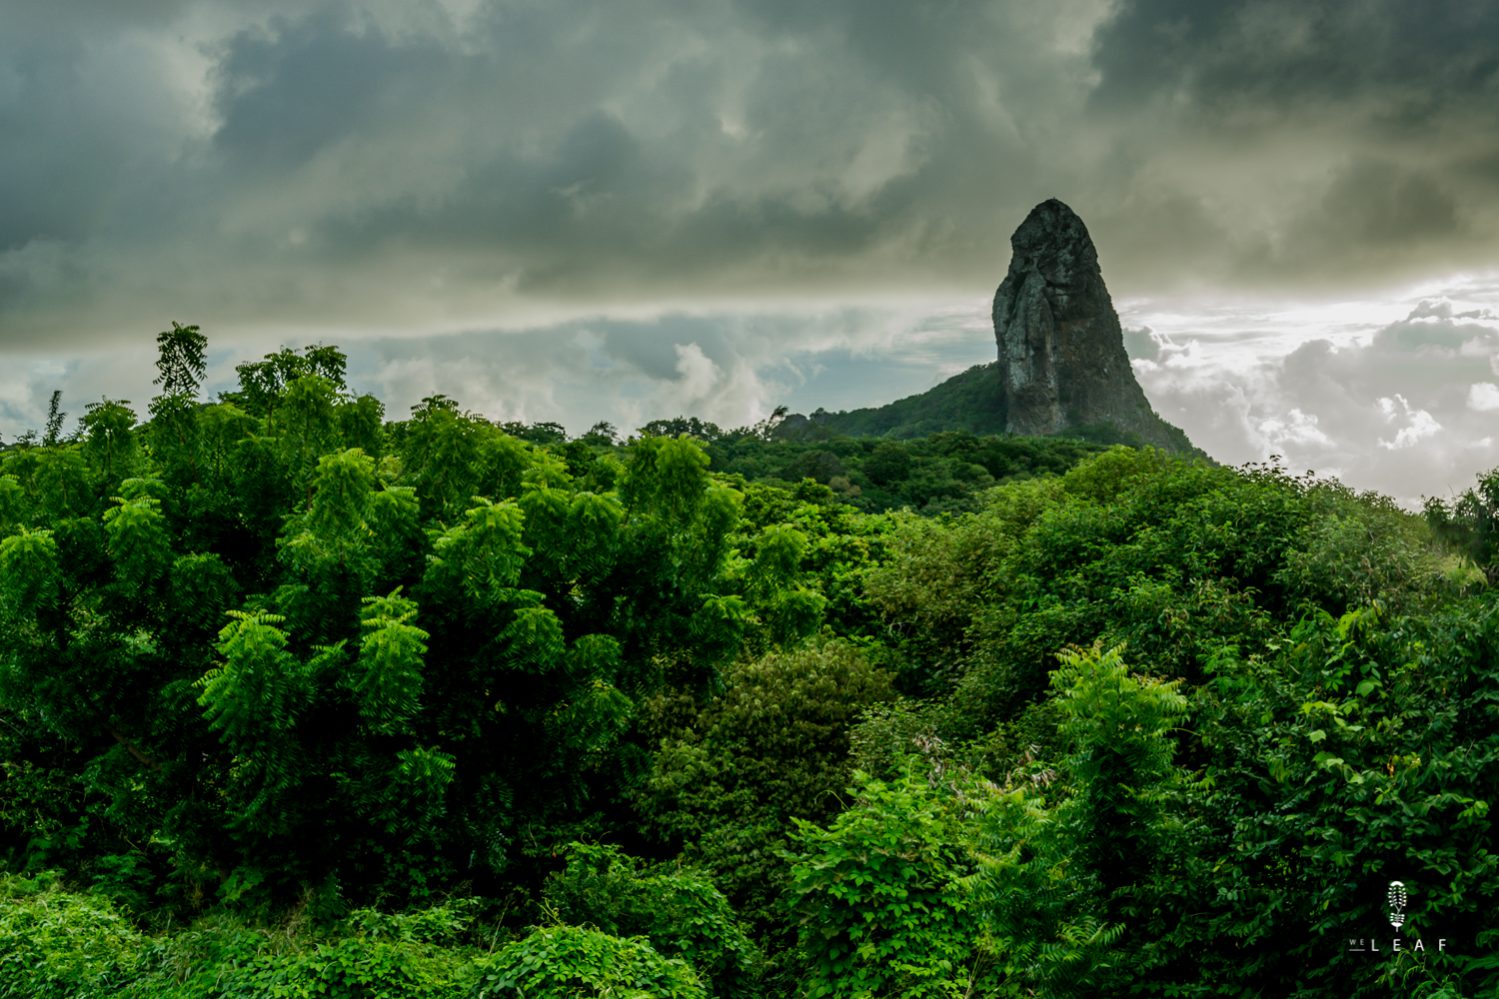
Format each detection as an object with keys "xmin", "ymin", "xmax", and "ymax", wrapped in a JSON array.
[{"xmin": 1130, "ymin": 292, "xmax": 1499, "ymax": 507}]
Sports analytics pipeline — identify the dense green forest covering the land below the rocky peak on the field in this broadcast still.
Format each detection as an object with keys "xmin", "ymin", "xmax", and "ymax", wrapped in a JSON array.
[{"xmin": 0, "ymin": 324, "xmax": 1499, "ymax": 999}]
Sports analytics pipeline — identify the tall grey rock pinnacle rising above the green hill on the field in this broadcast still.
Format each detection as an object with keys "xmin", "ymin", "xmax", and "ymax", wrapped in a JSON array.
[{"xmin": 994, "ymin": 198, "xmax": 1193, "ymax": 452}]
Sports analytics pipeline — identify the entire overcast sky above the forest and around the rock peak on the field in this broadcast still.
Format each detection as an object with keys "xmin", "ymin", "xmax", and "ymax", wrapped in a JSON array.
[{"xmin": 0, "ymin": 0, "xmax": 1499, "ymax": 501}]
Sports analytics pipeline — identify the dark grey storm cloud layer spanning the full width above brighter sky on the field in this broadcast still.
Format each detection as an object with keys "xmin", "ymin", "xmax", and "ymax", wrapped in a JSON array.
[{"xmin": 0, "ymin": 0, "xmax": 1499, "ymax": 341}]
